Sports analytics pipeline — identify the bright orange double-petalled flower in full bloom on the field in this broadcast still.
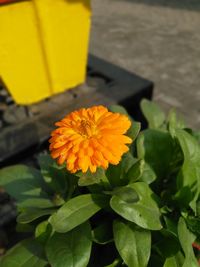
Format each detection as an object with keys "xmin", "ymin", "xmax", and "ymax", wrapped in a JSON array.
[{"xmin": 49, "ymin": 106, "xmax": 132, "ymax": 173}]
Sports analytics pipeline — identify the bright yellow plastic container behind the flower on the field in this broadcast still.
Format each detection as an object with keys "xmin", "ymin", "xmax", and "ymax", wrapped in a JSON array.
[{"xmin": 0, "ymin": 0, "xmax": 91, "ymax": 105}]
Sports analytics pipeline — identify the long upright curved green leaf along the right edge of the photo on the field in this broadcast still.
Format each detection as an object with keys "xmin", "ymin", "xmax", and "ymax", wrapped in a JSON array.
[{"xmin": 176, "ymin": 130, "xmax": 200, "ymax": 211}]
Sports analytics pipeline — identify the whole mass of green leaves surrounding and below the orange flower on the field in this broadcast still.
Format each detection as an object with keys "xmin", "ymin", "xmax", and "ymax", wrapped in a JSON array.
[{"xmin": 0, "ymin": 100, "xmax": 200, "ymax": 267}]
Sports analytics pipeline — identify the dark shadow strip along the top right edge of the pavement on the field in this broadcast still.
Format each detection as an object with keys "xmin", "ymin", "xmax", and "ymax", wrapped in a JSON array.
[{"xmin": 120, "ymin": 0, "xmax": 200, "ymax": 11}]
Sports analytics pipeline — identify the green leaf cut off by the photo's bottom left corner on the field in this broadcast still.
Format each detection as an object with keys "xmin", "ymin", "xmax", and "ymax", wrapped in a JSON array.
[{"xmin": 0, "ymin": 240, "xmax": 47, "ymax": 267}]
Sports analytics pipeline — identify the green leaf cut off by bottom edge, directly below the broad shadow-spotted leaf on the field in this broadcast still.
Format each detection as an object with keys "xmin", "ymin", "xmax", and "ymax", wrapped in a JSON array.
[{"xmin": 113, "ymin": 221, "xmax": 151, "ymax": 267}]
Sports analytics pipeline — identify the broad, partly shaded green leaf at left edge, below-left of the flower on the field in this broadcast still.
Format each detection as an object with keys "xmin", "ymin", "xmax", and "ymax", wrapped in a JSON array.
[{"xmin": 0, "ymin": 165, "xmax": 54, "ymax": 208}]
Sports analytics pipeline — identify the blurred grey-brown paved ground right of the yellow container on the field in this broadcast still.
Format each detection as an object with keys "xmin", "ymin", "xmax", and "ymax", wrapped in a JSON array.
[{"xmin": 90, "ymin": 0, "xmax": 200, "ymax": 128}]
